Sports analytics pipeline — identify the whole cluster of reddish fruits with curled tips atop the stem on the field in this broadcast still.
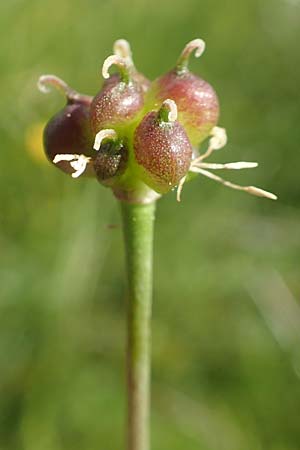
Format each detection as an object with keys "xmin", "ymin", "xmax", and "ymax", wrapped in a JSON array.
[{"xmin": 39, "ymin": 39, "xmax": 275, "ymax": 203}]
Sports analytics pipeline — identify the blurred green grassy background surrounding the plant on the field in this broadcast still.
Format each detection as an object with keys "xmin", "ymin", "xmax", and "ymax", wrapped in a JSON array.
[{"xmin": 0, "ymin": 0, "xmax": 300, "ymax": 450}]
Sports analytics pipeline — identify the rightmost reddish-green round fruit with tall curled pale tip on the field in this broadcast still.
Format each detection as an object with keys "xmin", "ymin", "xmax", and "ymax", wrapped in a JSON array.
[{"xmin": 147, "ymin": 39, "xmax": 219, "ymax": 146}]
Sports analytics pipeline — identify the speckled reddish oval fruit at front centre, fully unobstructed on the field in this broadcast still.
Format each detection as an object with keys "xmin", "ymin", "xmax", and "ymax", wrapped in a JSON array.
[{"xmin": 134, "ymin": 100, "xmax": 192, "ymax": 193}]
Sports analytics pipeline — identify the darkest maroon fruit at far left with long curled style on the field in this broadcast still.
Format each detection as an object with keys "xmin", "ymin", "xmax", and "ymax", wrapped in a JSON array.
[{"xmin": 39, "ymin": 75, "xmax": 94, "ymax": 178}]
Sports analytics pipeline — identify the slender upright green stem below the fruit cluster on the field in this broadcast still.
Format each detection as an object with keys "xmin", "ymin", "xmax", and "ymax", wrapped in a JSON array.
[{"xmin": 121, "ymin": 202, "xmax": 155, "ymax": 450}]
